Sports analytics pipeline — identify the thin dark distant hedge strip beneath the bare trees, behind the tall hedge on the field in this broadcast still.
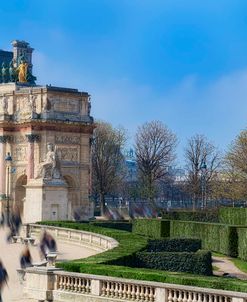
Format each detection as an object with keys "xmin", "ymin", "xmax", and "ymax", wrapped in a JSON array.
[{"xmin": 162, "ymin": 210, "xmax": 219, "ymax": 222}]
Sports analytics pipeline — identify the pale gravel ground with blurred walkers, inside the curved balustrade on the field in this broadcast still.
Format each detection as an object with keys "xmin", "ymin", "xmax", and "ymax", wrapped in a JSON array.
[{"xmin": 0, "ymin": 229, "xmax": 97, "ymax": 302}]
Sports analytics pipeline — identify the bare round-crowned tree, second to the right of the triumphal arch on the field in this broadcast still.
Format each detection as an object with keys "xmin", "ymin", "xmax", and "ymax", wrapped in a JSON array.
[{"xmin": 135, "ymin": 121, "xmax": 177, "ymax": 200}]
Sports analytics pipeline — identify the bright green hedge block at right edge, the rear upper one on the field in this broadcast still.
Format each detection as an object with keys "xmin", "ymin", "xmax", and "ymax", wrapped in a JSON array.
[{"xmin": 219, "ymin": 208, "xmax": 247, "ymax": 226}]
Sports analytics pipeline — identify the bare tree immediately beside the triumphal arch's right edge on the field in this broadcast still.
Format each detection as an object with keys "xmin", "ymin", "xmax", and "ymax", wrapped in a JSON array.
[{"xmin": 92, "ymin": 122, "xmax": 126, "ymax": 215}]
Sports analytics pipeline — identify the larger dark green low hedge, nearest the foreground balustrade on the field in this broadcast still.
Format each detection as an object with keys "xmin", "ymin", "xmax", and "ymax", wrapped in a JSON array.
[{"xmin": 135, "ymin": 251, "xmax": 213, "ymax": 276}]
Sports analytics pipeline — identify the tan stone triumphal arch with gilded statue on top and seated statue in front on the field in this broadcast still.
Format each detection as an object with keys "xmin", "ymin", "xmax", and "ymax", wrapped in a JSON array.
[{"xmin": 0, "ymin": 41, "xmax": 94, "ymax": 222}]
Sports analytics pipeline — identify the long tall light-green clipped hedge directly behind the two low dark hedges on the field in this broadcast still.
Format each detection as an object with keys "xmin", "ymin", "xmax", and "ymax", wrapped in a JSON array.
[{"xmin": 170, "ymin": 220, "xmax": 238, "ymax": 257}]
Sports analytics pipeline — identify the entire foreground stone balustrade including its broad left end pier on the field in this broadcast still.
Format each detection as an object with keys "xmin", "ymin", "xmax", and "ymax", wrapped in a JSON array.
[{"xmin": 25, "ymin": 268, "xmax": 247, "ymax": 302}]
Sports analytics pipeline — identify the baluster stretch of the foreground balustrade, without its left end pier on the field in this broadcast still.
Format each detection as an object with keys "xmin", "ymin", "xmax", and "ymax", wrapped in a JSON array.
[{"xmin": 49, "ymin": 272, "xmax": 247, "ymax": 302}]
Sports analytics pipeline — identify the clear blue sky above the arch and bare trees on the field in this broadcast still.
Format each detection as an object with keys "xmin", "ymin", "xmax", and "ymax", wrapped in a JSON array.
[{"xmin": 0, "ymin": 0, "xmax": 247, "ymax": 164}]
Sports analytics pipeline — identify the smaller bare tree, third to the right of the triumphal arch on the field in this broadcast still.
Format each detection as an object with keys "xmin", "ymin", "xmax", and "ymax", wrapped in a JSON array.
[{"xmin": 185, "ymin": 134, "xmax": 221, "ymax": 209}]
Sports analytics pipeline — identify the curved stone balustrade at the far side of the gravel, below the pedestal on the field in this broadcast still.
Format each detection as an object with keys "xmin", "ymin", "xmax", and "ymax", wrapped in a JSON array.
[{"xmin": 26, "ymin": 224, "xmax": 118, "ymax": 252}]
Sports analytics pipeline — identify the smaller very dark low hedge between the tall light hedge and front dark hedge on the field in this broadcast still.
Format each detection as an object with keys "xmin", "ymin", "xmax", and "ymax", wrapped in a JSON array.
[{"xmin": 146, "ymin": 238, "xmax": 202, "ymax": 252}]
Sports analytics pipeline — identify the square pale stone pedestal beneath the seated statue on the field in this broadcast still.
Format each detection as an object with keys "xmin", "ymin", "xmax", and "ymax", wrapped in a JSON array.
[{"xmin": 24, "ymin": 179, "xmax": 68, "ymax": 223}]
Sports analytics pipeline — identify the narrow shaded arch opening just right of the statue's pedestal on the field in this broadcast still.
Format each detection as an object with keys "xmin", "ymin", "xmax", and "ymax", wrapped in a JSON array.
[{"xmin": 63, "ymin": 175, "xmax": 79, "ymax": 219}]
